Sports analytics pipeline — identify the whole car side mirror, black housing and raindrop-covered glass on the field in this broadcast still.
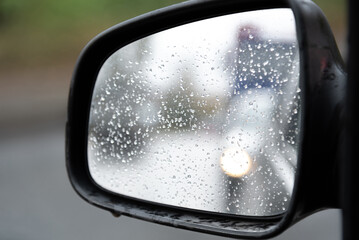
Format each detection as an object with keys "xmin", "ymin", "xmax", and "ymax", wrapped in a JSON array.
[{"xmin": 66, "ymin": 0, "xmax": 345, "ymax": 238}]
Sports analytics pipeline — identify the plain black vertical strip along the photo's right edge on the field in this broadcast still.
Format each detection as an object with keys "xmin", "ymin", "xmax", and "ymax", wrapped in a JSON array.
[{"xmin": 341, "ymin": 0, "xmax": 359, "ymax": 240}]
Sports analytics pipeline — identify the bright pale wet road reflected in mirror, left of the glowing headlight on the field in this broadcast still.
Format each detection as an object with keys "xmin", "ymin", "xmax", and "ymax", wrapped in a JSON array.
[{"xmin": 91, "ymin": 132, "xmax": 223, "ymax": 211}]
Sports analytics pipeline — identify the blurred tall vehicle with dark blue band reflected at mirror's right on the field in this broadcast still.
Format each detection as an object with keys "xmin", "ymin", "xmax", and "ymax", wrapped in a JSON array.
[{"xmin": 224, "ymin": 24, "xmax": 299, "ymax": 212}]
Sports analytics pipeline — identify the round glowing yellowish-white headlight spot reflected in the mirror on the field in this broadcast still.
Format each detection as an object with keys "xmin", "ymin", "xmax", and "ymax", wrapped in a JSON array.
[{"xmin": 220, "ymin": 147, "xmax": 252, "ymax": 178}]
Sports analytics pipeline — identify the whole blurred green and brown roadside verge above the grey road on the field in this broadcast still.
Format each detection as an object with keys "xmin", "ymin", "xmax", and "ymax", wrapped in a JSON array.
[{"xmin": 0, "ymin": 0, "xmax": 346, "ymax": 126}]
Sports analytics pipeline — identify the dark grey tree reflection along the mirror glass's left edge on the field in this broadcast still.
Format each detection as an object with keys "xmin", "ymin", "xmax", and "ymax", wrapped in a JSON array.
[{"xmin": 90, "ymin": 39, "xmax": 153, "ymax": 163}]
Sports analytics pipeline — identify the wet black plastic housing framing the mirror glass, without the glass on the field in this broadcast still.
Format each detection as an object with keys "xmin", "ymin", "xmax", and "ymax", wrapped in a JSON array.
[{"xmin": 66, "ymin": 0, "xmax": 346, "ymax": 238}]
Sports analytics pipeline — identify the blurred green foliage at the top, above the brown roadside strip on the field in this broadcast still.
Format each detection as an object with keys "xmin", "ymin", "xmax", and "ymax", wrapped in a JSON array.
[{"xmin": 0, "ymin": 0, "xmax": 345, "ymax": 69}]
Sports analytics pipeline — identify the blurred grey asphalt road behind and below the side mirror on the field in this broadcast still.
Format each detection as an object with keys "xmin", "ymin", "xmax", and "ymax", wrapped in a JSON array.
[{"xmin": 0, "ymin": 117, "xmax": 341, "ymax": 240}]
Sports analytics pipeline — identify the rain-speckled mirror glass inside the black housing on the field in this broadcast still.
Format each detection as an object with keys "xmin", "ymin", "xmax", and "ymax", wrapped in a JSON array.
[{"xmin": 88, "ymin": 9, "xmax": 301, "ymax": 216}]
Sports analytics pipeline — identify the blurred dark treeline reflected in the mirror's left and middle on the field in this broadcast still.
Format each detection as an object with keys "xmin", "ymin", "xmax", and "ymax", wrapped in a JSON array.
[{"xmin": 90, "ymin": 38, "xmax": 231, "ymax": 167}]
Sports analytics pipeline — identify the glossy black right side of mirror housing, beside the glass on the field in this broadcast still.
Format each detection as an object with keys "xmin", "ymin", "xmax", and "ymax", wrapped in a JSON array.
[{"xmin": 292, "ymin": 0, "xmax": 346, "ymax": 220}]
